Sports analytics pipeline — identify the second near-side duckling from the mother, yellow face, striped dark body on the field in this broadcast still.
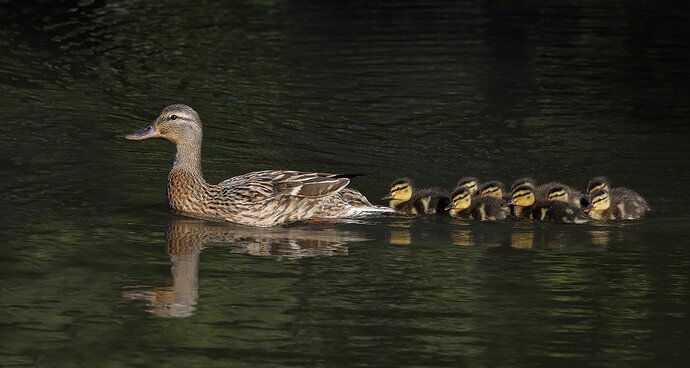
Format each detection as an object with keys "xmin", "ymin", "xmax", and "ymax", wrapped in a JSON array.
[{"xmin": 448, "ymin": 188, "xmax": 509, "ymax": 221}]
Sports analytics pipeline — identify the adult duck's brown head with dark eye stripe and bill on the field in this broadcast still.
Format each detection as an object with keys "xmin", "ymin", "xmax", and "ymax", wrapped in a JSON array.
[{"xmin": 125, "ymin": 104, "xmax": 201, "ymax": 143}]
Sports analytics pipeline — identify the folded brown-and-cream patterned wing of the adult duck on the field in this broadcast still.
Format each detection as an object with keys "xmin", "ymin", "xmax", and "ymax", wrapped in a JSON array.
[{"xmin": 218, "ymin": 170, "xmax": 350, "ymax": 202}]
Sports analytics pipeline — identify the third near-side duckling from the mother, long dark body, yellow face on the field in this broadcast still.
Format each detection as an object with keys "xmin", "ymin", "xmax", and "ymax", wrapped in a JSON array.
[{"xmin": 508, "ymin": 185, "xmax": 589, "ymax": 224}]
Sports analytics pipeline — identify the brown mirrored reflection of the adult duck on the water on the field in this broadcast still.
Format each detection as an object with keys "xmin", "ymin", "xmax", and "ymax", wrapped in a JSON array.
[{"xmin": 123, "ymin": 219, "xmax": 368, "ymax": 317}]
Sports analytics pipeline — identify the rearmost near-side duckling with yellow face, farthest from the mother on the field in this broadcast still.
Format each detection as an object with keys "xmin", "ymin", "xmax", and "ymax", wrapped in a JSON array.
[{"xmin": 585, "ymin": 188, "xmax": 651, "ymax": 220}]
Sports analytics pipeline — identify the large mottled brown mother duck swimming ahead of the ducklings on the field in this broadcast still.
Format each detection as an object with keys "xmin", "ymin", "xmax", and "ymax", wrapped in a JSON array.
[{"xmin": 125, "ymin": 105, "xmax": 390, "ymax": 226}]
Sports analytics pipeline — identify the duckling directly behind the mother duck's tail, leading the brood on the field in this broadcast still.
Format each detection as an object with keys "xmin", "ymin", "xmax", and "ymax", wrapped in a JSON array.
[{"xmin": 381, "ymin": 178, "xmax": 450, "ymax": 215}]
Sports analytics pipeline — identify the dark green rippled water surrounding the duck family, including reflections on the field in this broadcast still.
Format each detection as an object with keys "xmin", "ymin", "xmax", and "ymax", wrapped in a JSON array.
[{"xmin": 0, "ymin": 0, "xmax": 690, "ymax": 367}]
